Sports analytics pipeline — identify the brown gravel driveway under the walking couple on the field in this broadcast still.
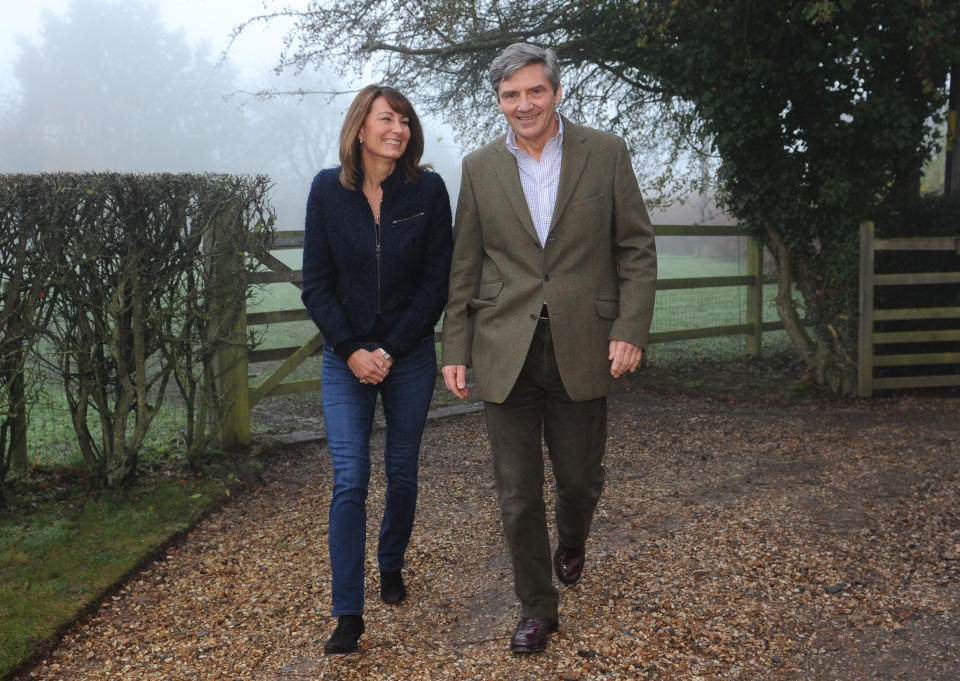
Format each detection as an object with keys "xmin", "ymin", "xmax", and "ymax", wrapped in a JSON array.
[{"xmin": 22, "ymin": 390, "xmax": 960, "ymax": 681}]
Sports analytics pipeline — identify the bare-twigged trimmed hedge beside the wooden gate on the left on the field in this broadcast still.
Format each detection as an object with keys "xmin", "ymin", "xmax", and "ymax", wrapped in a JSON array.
[{"xmin": 0, "ymin": 173, "xmax": 275, "ymax": 492}]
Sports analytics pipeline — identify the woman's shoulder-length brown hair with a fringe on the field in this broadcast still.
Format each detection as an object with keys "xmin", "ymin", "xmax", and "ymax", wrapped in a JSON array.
[{"xmin": 340, "ymin": 85, "xmax": 423, "ymax": 191}]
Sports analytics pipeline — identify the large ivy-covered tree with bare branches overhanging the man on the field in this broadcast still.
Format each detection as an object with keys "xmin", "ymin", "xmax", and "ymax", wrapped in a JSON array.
[{"xmin": 241, "ymin": 0, "xmax": 960, "ymax": 392}]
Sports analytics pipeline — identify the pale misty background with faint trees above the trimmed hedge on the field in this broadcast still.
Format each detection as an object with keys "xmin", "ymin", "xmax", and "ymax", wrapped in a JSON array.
[{"xmin": 0, "ymin": 0, "xmax": 461, "ymax": 229}]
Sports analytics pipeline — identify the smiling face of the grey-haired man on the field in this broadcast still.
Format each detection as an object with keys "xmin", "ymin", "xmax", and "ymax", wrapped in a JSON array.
[{"xmin": 497, "ymin": 64, "xmax": 561, "ymax": 150}]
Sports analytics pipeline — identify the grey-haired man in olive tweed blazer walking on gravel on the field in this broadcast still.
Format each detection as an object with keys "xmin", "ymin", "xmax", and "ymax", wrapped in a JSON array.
[{"xmin": 443, "ymin": 44, "xmax": 656, "ymax": 653}]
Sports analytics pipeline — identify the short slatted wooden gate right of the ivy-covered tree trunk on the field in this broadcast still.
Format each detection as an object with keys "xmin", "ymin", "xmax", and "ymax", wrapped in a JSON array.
[{"xmin": 857, "ymin": 222, "xmax": 960, "ymax": 397}]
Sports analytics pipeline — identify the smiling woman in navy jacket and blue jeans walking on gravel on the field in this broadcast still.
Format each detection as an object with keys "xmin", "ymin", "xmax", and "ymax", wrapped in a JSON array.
[{"xmin": 303, "ymin": 85, "xmax": 453, "ymax": 654}]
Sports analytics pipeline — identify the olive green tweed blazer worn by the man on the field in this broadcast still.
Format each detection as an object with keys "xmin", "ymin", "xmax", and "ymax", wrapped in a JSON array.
[{"xmin": 442, "ymin": 118, "xmax": 657, "ymax": 403}]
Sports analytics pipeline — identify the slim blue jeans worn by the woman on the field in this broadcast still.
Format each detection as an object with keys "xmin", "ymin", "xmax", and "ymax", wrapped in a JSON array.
[{"xmin": 321, "ymin": 336, "xmax": 437, "ymax": 617}]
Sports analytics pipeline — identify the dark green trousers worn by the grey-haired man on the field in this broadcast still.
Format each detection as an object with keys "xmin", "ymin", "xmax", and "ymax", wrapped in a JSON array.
[{"xmin": 484, "ymin": 320, "xmax": 607, "ymax": 619}]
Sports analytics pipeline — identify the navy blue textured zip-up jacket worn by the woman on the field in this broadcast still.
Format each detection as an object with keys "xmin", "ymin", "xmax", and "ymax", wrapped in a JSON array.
[{"xmin": 301, "ymin": 168, "xmax": 453, "ymax": 359}]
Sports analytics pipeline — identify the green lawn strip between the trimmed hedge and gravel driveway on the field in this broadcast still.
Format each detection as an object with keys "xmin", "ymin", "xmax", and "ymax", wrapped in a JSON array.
[{"xmin": 0, "ymin": 454, "xmax": 260, "ymax": 678}]
